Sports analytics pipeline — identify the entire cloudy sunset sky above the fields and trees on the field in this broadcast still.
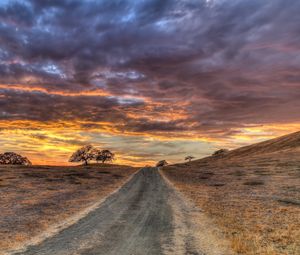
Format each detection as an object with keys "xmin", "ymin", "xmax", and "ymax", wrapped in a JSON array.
[{"xmin": 0, "ymin": 0, "xmax": 300, "ymax": 165}]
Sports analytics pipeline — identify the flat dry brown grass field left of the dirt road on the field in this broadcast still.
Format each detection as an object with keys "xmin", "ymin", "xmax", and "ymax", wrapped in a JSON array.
[{"xmin": 0, "ymin": 165, "xmax": 138, "ymax": 254}]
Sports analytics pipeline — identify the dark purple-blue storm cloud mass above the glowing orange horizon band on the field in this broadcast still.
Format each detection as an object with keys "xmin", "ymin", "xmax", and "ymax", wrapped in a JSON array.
[{"xmin": 0, "ymin": 0, "xmax": 300, "ymax": 134}]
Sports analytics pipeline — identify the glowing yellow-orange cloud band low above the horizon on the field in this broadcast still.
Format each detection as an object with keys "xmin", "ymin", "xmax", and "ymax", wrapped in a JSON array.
[{"xmin": 0, "ymin": 120, "xmax": 300, "ymax": 166}]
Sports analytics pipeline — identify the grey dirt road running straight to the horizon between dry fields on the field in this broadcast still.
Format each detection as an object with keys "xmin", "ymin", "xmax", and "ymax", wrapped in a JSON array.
[{"xmin": 17, "ymin": 168, "xmax": 203, "ymax": 255}]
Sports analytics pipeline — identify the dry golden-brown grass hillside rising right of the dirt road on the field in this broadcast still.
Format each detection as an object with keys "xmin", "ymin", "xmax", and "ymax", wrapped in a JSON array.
[{"xmin": 163, "ymin": 132, "xmax": 300, "ymax": 255}]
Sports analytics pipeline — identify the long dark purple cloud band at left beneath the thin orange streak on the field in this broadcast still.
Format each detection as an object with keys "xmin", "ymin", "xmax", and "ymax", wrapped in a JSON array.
[{"xmin": 0, "ymin": 90, "xmax": 134, "ymax": 121}]
